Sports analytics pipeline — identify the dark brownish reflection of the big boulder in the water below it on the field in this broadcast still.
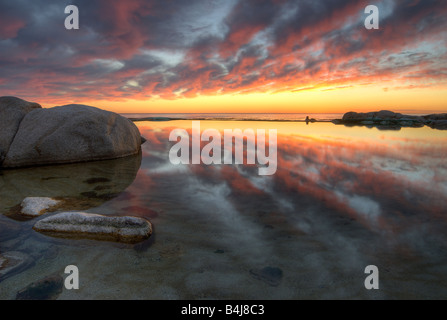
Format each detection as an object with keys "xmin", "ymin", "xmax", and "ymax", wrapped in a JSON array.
[{"xmin": 0, "ymin": 152, "xmax": 141, "ymax": 219}]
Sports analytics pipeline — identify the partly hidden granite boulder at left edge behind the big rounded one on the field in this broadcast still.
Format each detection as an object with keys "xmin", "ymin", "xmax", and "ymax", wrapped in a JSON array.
[{"xmin": 0, "ymin": 97, "xmax": 42, "ymax": 164}]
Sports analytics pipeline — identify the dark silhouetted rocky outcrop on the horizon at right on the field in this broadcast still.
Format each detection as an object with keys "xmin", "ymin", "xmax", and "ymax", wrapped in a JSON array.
[{"xmin": 332, "ymin": 110, "xmax": 447, "ymax": 130}]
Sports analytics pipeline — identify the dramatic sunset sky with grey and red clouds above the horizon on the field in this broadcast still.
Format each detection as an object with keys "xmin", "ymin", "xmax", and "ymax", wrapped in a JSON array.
[{"xmin": 0, "ymin": 0, "xmax": 447, "ymax": 113}]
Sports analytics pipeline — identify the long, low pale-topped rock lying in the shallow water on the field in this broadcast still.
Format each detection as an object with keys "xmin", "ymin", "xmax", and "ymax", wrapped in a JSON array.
[{"xmin": 33, "ymin": 212, "xmax": 152, "ymax": 243}]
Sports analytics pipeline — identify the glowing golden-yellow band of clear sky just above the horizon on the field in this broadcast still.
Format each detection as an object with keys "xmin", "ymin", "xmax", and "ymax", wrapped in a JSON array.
[{"xmin": 61, "ymin": 85, "xmax": 447, "ymax": 113}]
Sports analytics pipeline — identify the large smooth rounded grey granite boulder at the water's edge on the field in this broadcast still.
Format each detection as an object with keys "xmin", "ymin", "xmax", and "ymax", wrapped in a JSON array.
[{"xmin": 0, "ymin": 101, "xmax": 142, "ymax": 168}]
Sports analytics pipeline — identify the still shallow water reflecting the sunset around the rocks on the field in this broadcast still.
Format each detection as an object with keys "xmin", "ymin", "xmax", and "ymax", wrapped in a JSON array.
[{"xmin": 0, "ymin": 121, "xmax": 447, "ymax": 299}]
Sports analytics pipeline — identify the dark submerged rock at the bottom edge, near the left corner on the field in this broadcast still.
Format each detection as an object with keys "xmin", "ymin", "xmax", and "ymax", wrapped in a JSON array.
[{"xmin": 16, "ymin": 275, "xmax": 64, "ymax": 300}]
